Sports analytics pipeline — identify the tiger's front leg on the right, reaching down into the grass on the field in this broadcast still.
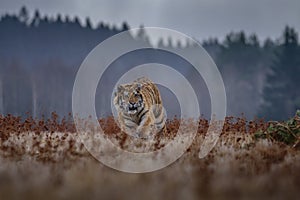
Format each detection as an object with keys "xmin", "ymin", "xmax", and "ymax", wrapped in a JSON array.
[{"xmin": 136, "ymin": 113, "xmax": 154, "ymax": 139}]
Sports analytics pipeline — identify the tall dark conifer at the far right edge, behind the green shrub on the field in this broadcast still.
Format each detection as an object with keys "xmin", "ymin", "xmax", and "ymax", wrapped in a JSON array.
[{"xmin": 260, "ymin": 27, "xmax": 300, "ymax": 120}]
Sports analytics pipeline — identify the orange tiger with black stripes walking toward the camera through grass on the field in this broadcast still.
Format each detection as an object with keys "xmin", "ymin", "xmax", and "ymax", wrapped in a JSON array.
[{"xmin": 113, "ymin": 77, "xmax": 166, "ymax": 139}]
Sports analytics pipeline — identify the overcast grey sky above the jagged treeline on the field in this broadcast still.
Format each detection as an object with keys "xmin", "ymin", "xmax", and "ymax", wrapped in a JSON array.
[{"xmin": 0, "ymin": 0, "xmax": 300, "ymax": 40}]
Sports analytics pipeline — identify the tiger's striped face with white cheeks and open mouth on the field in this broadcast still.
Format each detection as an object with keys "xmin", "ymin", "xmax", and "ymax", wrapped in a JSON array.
[{"xmin": 114, "ymin": 84, "xmax": 144, "ymax": 115}]
